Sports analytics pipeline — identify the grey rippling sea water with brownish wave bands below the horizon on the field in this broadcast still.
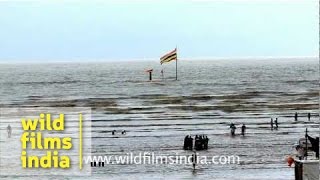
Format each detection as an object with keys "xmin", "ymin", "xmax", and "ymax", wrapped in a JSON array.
[{"xmin": 0, "ymin": 59, "xmax": 319, "ymax": 179}]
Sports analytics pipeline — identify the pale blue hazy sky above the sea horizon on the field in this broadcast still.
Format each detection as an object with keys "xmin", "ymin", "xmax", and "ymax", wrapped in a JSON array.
[{"xmin": 0, "ymin": 0, "xmax": 319, "ymax": 62}]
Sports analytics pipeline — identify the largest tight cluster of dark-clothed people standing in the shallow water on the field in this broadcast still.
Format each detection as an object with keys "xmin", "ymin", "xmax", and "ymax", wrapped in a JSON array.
[{"xmin": 183, "ymin": 135, "xmax": 209, "ymax": 150}]
